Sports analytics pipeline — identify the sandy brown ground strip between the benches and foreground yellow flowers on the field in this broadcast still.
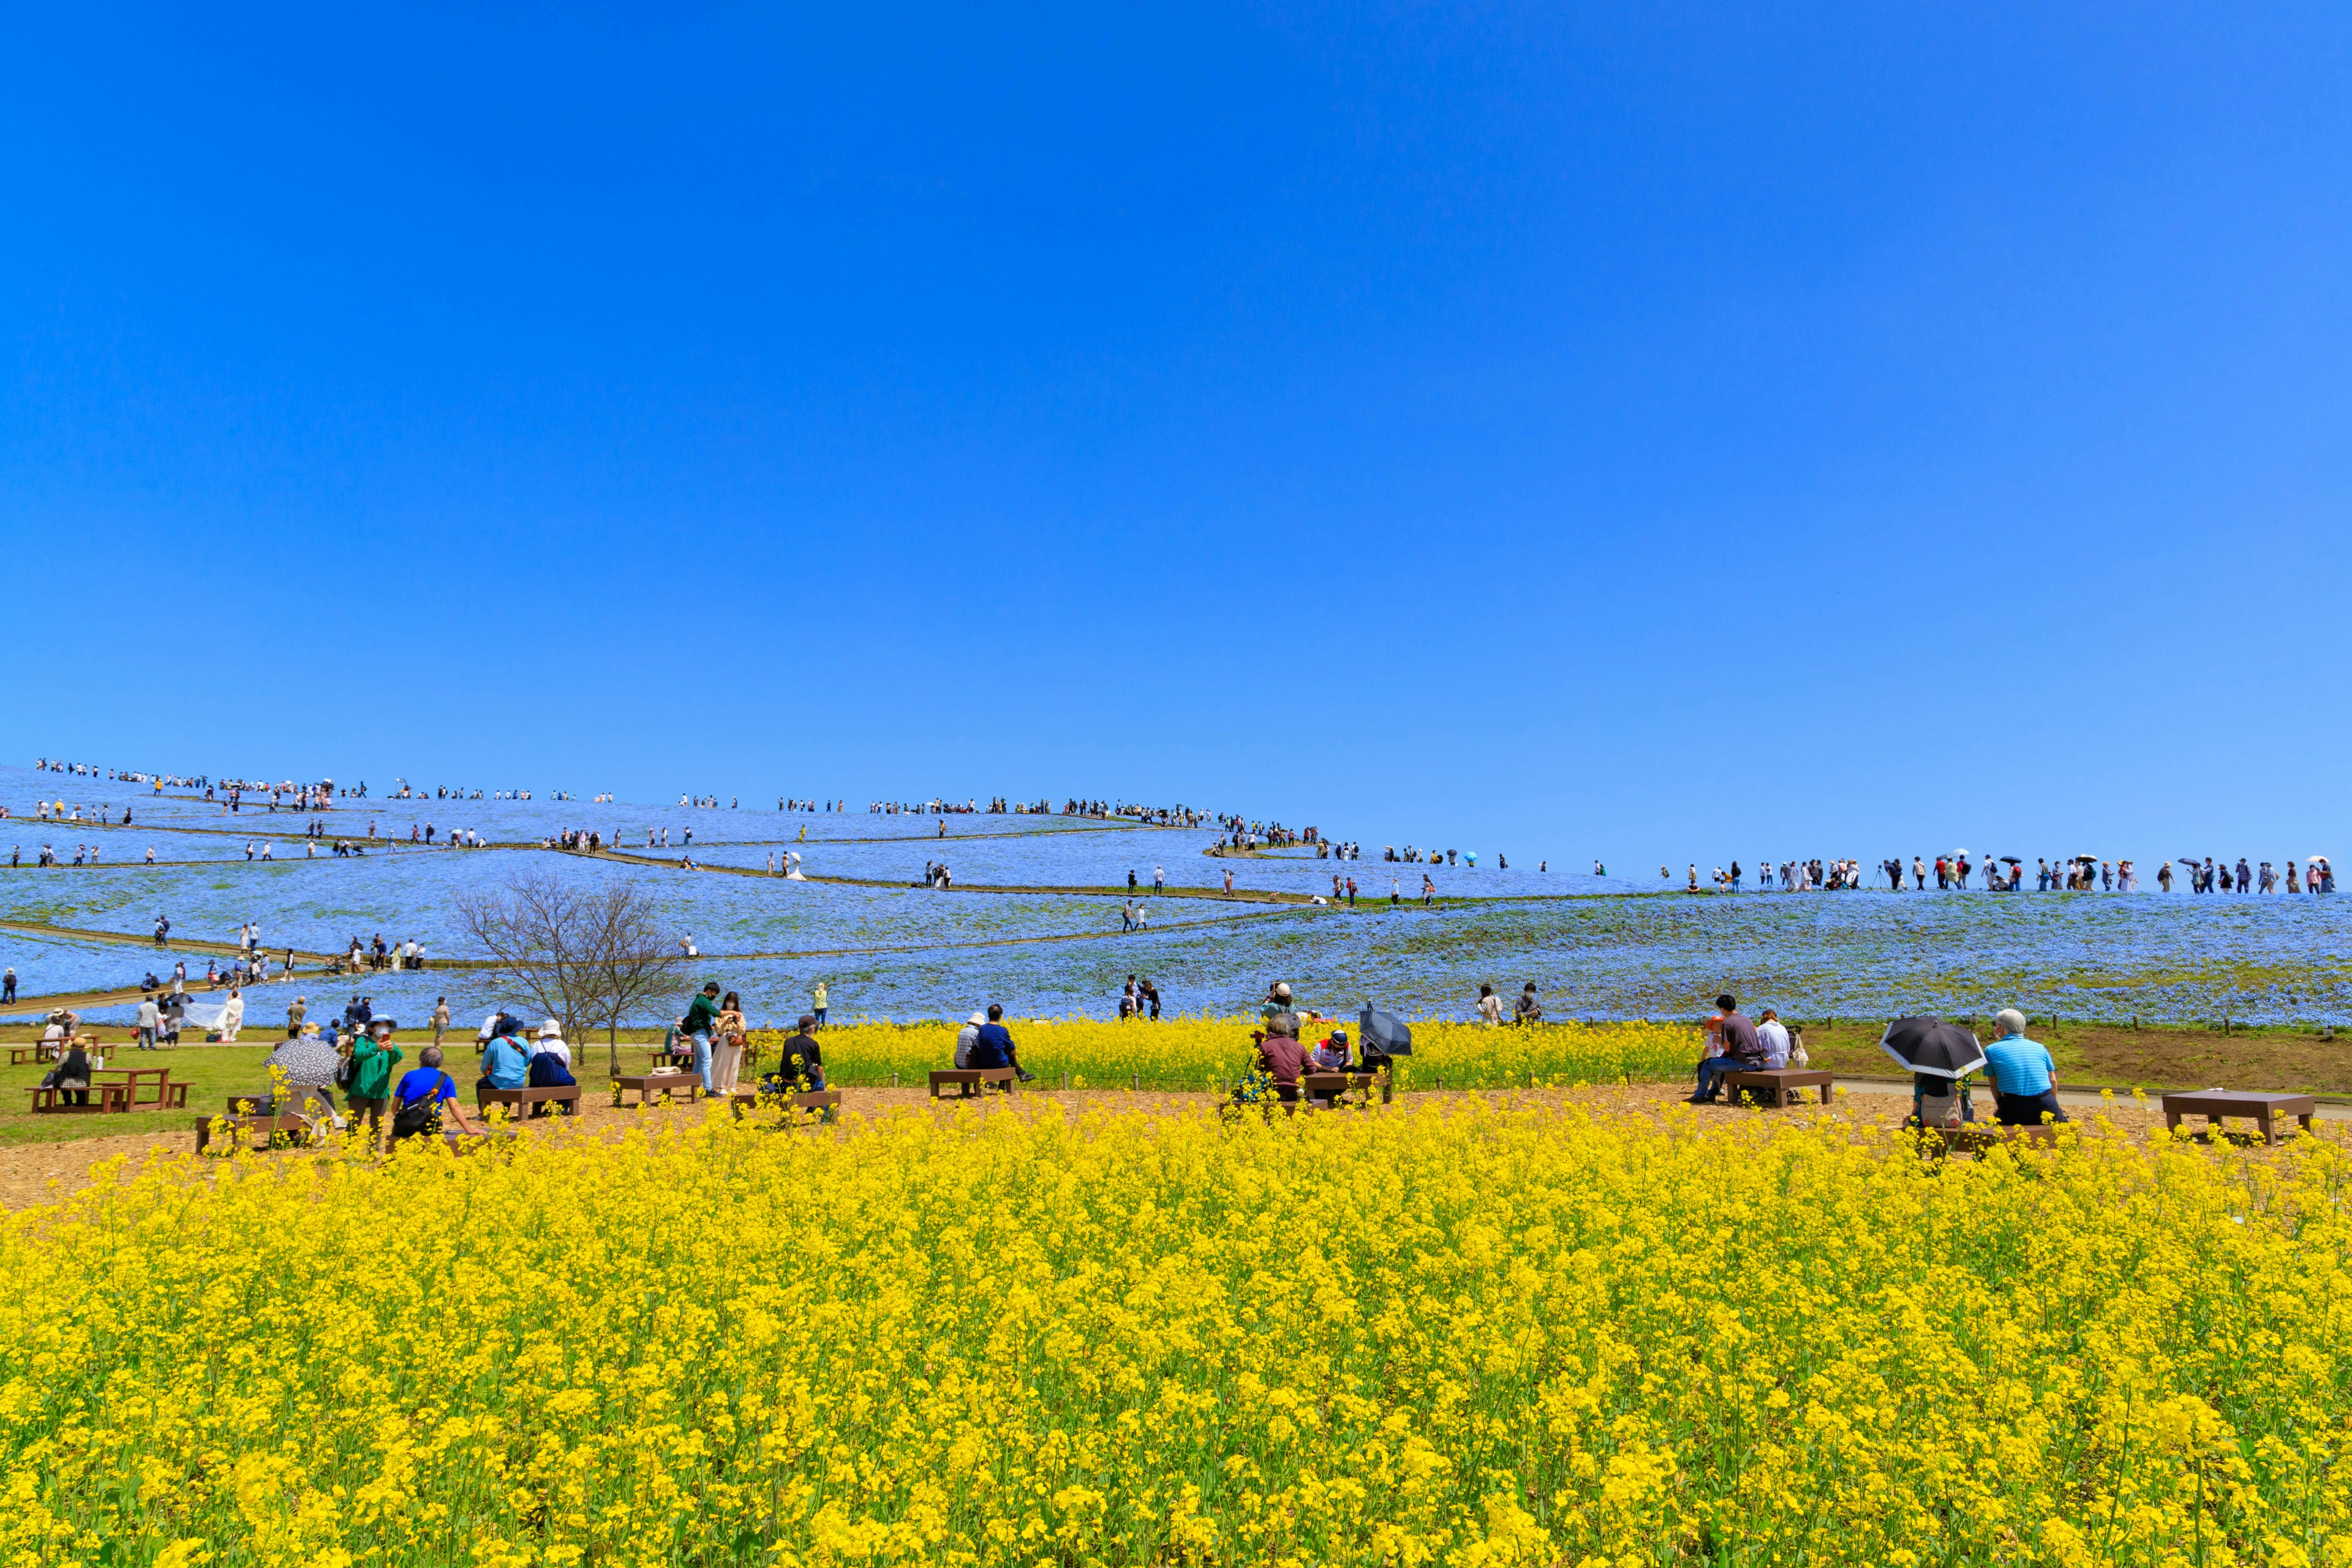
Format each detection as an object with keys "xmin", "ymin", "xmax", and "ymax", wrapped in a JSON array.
[{"xmin": 0, "ymin": 1084, "xmax": 2314, "ymax": 1211}]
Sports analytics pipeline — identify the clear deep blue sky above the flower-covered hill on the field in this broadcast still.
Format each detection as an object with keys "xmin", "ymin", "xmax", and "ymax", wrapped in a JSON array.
[{"xmin": 0, "ymin": 5, "xmax": 2352, "ymax": 870}]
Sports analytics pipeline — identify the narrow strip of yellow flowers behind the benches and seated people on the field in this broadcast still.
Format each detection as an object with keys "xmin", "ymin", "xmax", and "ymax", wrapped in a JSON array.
[{"xmin": 760, "ymin": 1018, "xmax": 1698, "ymax": 1088}]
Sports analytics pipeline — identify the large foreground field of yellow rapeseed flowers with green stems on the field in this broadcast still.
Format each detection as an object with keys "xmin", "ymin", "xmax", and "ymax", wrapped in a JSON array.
[{"xmin": 0, "ymin": 1100, "xmax": 2352, "ymax": 1566}]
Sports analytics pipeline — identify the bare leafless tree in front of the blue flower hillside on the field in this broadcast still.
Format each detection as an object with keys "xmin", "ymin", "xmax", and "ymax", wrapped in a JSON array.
[{"xmin": 456, "ymin": 872, "xmax": 684, "ymax": 1072}]
